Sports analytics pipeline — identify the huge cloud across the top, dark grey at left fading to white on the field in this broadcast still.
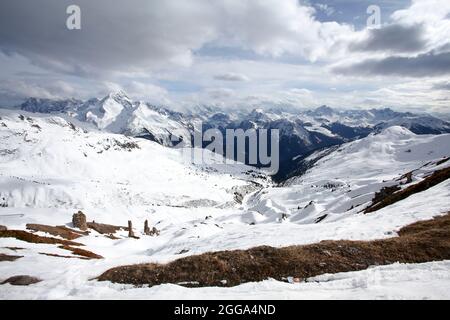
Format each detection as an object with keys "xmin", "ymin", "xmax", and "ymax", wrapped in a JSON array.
[{"xmin": 0, "ymin": 0, "xmax": 351, "ymax": 77}]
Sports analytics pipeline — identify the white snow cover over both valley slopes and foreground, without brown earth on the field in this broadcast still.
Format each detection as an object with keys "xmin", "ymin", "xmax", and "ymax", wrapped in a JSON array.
[{"xmin": 0, "ymin": 110, "xmax": 450, "ymax": 299}]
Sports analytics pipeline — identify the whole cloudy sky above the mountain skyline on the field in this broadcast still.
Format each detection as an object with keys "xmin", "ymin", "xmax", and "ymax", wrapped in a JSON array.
[{"xmin": 0, "ymin": 0, "xmax": 450, "ymax": 113}]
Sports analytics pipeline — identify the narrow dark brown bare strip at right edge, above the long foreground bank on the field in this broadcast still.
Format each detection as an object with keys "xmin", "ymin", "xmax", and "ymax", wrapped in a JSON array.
[{"xmin": 364, "ymin": 167, "xmax": 450, "ymax": 213}]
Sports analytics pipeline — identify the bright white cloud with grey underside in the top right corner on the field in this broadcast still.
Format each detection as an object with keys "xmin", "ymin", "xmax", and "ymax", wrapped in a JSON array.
[{"xmin": 331, "ymin": 0, "xmax": 450, "ymax": 79}]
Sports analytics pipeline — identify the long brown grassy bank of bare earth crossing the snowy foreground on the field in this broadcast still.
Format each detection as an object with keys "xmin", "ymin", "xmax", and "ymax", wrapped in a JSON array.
[{"xmin": 98, "ymin": 214, "xmax": 450, "ymax": 286}]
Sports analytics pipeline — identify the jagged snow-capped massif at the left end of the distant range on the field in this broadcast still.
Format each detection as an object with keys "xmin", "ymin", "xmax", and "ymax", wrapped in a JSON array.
[{"xmin": 20, "ymin": 91, "xmax": 192, "ymax": 146}]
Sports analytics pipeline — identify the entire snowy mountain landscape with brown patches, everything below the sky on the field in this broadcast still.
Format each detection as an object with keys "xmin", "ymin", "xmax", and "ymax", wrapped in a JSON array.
[{"xmin": 0, "ymin": 93, "xmax": 450, "ymax": 299}]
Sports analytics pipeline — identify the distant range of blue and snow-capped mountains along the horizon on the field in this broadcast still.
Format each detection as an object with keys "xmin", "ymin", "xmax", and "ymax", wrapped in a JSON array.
[{"xmin": 12, "ymin": 92, "xmax": 450, "ymax": 181}]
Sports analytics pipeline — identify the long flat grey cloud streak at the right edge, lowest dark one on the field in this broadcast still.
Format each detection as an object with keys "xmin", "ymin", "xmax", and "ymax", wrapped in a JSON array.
[{"xmin": 333, "ymin": 52, "xmax": 450, "ymax": 77}]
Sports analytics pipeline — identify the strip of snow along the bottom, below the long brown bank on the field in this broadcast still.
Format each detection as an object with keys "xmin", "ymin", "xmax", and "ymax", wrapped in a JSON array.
[{"xmin": 0, "ymin": 257, "xmax": 450, "ymax": 300}]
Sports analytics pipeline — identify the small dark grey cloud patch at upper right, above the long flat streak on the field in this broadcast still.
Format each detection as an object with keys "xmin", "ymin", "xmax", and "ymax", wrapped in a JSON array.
[{"xmin": 350, "ymin": 24, "xmax": 426, "ymax": 53}]
